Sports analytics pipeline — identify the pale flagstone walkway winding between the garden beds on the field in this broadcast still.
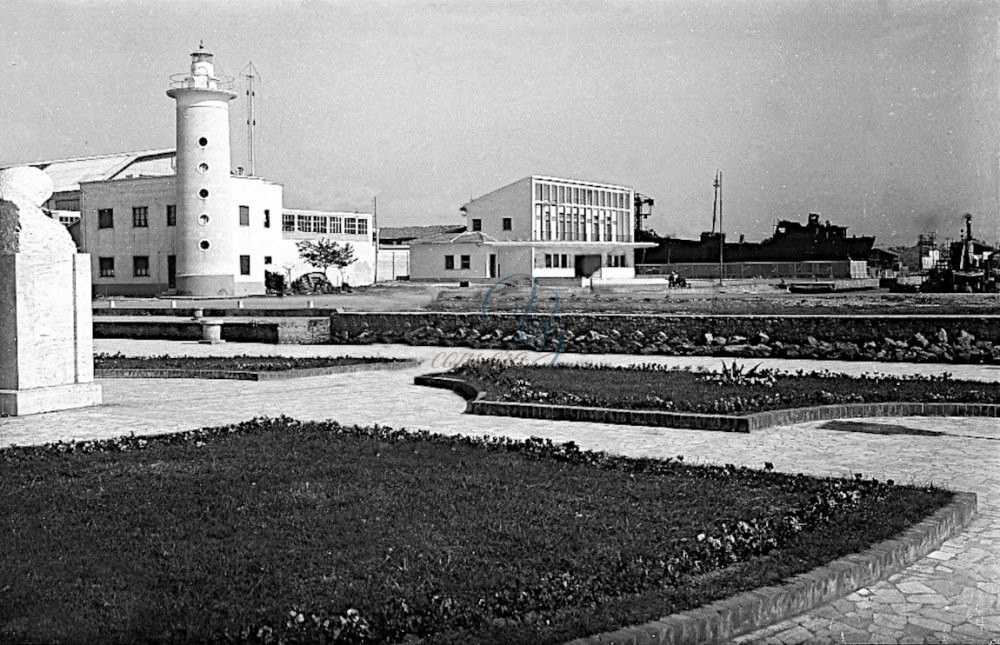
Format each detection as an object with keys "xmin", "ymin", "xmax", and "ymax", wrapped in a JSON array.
[{"xmin": 0, "ymin": 340, "xmax": 1000, "ymax": 644}]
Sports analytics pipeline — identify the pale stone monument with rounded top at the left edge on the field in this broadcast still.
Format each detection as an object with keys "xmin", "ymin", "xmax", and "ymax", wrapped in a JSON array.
[{"xmin": 0, "ymin": 167, "xmax": 101, "ymax": 416}]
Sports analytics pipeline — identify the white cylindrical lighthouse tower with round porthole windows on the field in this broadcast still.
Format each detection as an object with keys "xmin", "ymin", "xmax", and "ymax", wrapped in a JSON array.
[{"xmin": 167, "ymin": 46, "xmax": 239, "ymax": 296}]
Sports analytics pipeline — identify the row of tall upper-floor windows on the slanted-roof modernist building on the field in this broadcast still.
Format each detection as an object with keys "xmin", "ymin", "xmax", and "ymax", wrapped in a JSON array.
[{"xmin": 533, "ymin": 204, "xmax": 632, "ymax": 242}]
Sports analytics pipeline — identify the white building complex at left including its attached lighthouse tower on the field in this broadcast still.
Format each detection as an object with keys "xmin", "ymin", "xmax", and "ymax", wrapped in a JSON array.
[{"xmin": 1, "ymin": 49, "xmax": 376, "ymax": 296}]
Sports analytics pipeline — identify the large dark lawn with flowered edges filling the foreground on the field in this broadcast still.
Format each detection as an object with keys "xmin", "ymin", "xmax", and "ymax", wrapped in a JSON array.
[{"xmin": 0, "ymin": 419, "xmax": 951, "ymax": 644}]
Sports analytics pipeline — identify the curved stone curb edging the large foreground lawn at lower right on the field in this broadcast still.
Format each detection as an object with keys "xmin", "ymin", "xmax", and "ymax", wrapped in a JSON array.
[{"xmin": 567, "ymin": 493, "xmax": 976, "ymax": 645}]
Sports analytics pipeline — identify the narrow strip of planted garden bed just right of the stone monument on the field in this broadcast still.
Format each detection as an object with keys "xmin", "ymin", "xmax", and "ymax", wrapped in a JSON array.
[{"xmin": 94, "ymin": 354, "xmax": 399, "ymax": 372}]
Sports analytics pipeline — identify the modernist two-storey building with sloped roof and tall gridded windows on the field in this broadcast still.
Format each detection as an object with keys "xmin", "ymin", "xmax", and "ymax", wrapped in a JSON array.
[{"xmin": 410, "ymin": 175, "xmax": 654, "ymax": 282}]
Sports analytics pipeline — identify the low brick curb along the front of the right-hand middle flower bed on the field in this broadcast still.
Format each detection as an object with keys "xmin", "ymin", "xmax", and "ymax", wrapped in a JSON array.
[{"xmin": 413, "ymin": 375, "xmax": 1000, "ymax": 432}]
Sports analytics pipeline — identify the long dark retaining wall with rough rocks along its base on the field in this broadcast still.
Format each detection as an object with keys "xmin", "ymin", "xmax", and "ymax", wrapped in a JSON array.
[{"xmin": 330, "ymin": 312, "xmax": 1000, "ymax": 363}]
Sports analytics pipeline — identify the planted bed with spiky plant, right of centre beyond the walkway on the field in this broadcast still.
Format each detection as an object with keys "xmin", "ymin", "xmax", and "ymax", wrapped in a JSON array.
[{"xmin": 446, "ymin": 362, "xmax": 1000, "ymax": 415}]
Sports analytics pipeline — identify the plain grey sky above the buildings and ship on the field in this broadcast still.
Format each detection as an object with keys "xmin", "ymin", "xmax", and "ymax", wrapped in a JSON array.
[{"xmin": 0, "ymin": 0, "xmax": 1000, "ymax": 246}]
